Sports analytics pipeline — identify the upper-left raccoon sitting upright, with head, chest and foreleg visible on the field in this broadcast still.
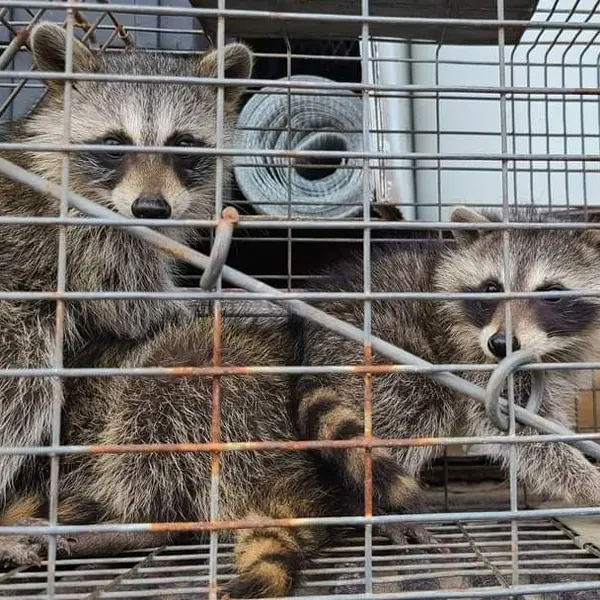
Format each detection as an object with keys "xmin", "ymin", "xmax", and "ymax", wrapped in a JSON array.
[{"xmin": 0, "ymin": 22, "xmax": 252, "ymax": 506}]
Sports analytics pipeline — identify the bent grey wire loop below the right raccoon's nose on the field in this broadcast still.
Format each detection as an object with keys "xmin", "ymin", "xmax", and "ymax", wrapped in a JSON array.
[{"xmin": 485, "ymin": 348, "xmax": 546, "ymax": 431}]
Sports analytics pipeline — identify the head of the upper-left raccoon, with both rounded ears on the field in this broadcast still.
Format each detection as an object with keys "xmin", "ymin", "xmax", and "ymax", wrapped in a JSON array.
[{"xmin": 27, "ymin": 23, "xmax": 252, "ymax": 224}]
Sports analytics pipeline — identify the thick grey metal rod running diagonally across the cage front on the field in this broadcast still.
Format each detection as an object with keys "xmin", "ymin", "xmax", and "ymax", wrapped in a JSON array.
[{"xmin": 0, "ymin": 158, "xmax": 600, "ymax": 458}]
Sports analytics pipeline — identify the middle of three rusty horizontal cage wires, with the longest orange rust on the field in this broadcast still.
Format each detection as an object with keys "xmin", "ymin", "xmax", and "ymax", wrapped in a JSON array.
[{"xmin": 0, "ymin": 432, "xmax": 600, "ymax": 456}]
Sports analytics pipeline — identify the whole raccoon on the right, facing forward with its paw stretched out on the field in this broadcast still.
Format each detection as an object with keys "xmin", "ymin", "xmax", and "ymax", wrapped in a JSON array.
[{"xmin": 295, "ymin": 208, "xmax": 600, "ymax": 512}]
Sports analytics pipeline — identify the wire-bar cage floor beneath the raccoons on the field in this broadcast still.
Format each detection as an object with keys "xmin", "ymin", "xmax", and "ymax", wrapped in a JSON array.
[{"xmin": 0, "ymin": 520, "xmax": 600, "ymax": 600}]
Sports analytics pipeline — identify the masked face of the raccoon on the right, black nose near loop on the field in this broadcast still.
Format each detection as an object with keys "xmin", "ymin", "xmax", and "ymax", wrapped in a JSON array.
[{"xmin": 436, "ymin": 208, "xmax": 600, "ymax": 361}]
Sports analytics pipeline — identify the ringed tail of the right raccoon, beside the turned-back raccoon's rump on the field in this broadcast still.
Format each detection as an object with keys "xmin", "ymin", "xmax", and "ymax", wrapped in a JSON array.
[{"xmin": 296, "ymin": 387, "xmax": 422, "ymax": 513}]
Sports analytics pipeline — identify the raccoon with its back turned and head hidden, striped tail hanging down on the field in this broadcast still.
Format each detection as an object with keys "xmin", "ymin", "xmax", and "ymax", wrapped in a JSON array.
[{"xmin": 0, "ymin": 317, "xmax": 396, "ymax": 598}]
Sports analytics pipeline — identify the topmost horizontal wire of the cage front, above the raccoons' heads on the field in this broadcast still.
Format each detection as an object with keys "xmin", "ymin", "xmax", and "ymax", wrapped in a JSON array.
[{"xmin": 2, "ymin": 0, "xmax": 598, "ymax": 31}]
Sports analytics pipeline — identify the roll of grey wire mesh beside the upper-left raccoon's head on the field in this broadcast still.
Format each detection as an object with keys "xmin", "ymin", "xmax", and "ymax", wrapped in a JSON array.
[{"xmin": 234, "ymin": 75, "xmax": 363, "ymax": 219}]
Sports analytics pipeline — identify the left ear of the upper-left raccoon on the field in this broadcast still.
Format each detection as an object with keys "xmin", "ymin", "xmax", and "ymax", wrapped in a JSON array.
[{"xmin": 30, "ymin": 22, "xmax": 97, "ymax": 87}]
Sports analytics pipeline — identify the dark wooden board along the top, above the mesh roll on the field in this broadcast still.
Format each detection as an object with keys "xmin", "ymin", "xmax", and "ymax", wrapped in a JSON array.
[{"xmin": 190, "ymin": 0, "xmax": 537, "ymax": 45}]
